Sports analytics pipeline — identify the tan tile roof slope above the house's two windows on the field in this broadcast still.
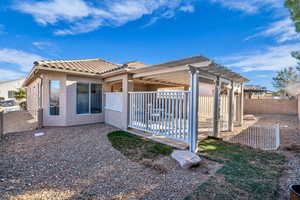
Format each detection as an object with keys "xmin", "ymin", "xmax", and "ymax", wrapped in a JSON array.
[{"xmin": 34, "ymin": 59, "xmax": 124, "ymax": 74}]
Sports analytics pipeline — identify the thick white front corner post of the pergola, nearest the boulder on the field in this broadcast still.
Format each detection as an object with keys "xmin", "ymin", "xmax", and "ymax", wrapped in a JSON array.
[{"xmin": 188, "ymin": 68, "xmax": 199, "ymax": 153}]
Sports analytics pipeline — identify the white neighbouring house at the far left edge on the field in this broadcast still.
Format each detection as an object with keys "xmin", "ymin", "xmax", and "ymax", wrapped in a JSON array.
[{"xmin": 0, "ymin": 78, "xmax": 25, "ymax": 100}]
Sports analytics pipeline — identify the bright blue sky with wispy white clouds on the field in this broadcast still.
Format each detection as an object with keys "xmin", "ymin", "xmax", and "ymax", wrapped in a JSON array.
[{"xmin": 0, "ymin": 0, "xmax": 300, "ymax": 89}]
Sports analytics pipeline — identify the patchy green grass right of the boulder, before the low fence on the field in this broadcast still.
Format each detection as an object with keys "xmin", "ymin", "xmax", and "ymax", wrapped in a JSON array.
[{"xmin": 186, "ymin": 139, "xmax": 285, "ymax": 200}]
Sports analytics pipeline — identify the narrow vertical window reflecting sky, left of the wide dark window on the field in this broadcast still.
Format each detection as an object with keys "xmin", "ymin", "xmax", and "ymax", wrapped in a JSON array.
[{"xmin": 49, "ymin": 81, "xmax": 60, "ymax": 115}]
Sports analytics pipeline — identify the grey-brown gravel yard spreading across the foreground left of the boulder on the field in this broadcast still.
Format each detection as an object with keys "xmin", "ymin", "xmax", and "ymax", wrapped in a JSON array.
[{"xmin": 0, "ymin": 124, "xmax": 221, "ymax": 200}]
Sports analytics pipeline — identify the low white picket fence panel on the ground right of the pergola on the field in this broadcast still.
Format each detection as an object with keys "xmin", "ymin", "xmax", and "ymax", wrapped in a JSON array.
[{"xmin": 229, "ymin": 125, "xmax": 280, "ymax": 150}]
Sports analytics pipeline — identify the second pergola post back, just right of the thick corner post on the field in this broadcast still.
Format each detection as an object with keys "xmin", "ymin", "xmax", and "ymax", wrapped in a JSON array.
[{"xmin": 213, "ymin": 77, "xmax": 221, "ymax": 138}]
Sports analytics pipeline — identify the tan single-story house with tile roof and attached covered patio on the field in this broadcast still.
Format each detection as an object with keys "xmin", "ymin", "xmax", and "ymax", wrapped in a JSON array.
[{"xmin": 24, "ymin": 56, "xmax": 248, "ymax": 151}]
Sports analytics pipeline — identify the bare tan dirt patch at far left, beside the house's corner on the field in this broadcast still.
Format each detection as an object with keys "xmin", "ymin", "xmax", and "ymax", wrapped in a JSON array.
[{"xmin": 3, "ymin": 111, "xmax": 37, "ymax": 134}]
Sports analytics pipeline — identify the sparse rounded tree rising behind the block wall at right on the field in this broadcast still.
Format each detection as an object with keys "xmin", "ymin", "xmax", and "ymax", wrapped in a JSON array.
[{"xmin": 272, "ymin": 67, "xmax": 299, "ymax": 96}]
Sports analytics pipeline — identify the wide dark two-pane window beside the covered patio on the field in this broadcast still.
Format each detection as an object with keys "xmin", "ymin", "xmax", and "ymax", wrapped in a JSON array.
[{"xmin": 76, "ymin": 83, "xmax": 102, "ymax": 114}]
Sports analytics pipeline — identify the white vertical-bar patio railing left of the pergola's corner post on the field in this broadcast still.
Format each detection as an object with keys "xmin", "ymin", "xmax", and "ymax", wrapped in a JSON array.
[{"xmin": 129, "ymin": 91, "xmax": 190, "ymax": 142}]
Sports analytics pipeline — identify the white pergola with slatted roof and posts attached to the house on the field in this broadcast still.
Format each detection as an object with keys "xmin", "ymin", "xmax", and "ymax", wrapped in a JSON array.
[{"xmin": 103, "ymin": 56, "xmax": 248, "ymax": 152}]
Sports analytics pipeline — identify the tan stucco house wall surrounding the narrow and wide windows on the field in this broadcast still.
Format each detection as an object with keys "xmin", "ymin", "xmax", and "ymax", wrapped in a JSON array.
[{"xmin": 27, "ymin": 72, "xmax": 104, "ymax": 126}]
